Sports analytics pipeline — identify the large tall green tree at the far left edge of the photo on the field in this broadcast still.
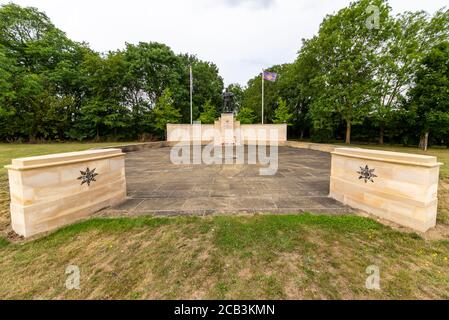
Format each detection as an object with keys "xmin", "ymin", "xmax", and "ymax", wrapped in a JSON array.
[{"xmin": 0, "ymin": 4, "xmax": 90, "ymax": 141}]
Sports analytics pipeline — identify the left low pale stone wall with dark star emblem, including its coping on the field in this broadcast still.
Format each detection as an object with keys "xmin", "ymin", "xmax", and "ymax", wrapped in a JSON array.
[{"xmin": 6, "ymin": 149, "xmax": 126, "ymax": 237}]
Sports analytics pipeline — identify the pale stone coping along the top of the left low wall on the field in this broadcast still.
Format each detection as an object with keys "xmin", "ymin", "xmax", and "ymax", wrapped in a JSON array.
[{"xmin": 5, "ymin": 149, "xmax": 125, "ymax": 171}]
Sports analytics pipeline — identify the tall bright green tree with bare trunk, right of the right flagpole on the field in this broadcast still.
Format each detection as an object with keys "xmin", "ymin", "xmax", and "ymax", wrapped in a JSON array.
[{"xmin": 301, "ymin": 0, "xmax": 389, "ymax": 144}]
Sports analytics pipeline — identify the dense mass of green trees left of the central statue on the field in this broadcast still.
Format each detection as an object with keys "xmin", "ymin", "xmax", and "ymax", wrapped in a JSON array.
[{"xmin": 0, "ymin": 4, "xmax": 223, "ymax": 141}]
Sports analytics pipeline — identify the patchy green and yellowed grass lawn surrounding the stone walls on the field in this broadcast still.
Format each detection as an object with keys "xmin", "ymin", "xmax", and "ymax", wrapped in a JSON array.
[{"xmin": 0, "ymin": 143, "xmax": 449, "ymax": 299}]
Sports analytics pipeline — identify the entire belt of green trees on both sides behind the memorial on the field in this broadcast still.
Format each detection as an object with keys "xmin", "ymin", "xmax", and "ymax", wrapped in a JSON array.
[{"xmin": 0, "ymin": 0, "xmax": 449, "ymax": 146}]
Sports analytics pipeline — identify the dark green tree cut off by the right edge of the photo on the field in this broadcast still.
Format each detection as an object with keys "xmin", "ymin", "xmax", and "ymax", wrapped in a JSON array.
[{"xmin": 410, "ymin": 42, "xmax": 449, "ymax": 150}]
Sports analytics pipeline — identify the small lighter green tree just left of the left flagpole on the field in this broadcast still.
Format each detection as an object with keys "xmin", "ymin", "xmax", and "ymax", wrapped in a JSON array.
[{"xmin": 153, "ymin": 89, "xmax": 181, "ymax": 137}]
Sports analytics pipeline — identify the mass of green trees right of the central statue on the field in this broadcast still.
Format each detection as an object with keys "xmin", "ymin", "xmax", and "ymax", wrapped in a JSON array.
[{"xmin": 242, "ymin": 0, "xmax": 449, "ymax": 145}]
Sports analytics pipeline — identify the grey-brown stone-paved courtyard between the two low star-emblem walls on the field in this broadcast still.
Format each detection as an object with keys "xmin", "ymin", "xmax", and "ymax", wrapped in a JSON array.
[{"xmin": 108, "ymin": 147, "xmax": 352, "ymax": 215}]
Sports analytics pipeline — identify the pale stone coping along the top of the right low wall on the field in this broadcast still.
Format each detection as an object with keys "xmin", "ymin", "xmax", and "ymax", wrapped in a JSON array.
[{"xmin": 331, "ymin": 148, "xmax": 442, "ymax": 168}]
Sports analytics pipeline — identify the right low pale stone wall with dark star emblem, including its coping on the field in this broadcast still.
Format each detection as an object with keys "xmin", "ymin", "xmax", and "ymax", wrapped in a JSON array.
[{"xmin": 330, "ymin": 148, "xmax": 441, "ymax": 232}]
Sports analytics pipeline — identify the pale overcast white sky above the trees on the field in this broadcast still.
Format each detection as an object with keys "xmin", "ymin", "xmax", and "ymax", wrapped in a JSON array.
[{"xmin": 0, "ymin": 0, "xmax": 449, "ymax": 85}]
